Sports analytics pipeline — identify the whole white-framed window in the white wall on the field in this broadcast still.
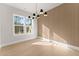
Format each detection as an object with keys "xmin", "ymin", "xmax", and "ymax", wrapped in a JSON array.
[{"xmin": 13, "ymin": 15, "xmax": 32, "ymax": 34}]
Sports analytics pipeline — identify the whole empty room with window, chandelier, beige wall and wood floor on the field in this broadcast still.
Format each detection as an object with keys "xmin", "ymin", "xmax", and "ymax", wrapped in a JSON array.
[{"xmin": 0, "ymin": 3, "xmax": 79, "ymax": 56}]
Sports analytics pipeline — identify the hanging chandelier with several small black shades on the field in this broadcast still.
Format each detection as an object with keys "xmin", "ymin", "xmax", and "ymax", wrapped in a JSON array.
[{"xmin": 28, "ymin": 3, "xmax": 47, "ymax": 19}]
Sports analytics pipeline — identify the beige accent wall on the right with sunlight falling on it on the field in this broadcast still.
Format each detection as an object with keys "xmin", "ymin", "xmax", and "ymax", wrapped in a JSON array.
[{"xmin": 38, "ymin": 3, "xmax": 79, "ymax": 47}]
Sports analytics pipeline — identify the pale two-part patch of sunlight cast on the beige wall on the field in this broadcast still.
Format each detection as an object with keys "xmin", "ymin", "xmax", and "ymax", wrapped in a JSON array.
[{"xmin": 42, "ymin": 24, "xmax": 67, "ymax": 44}]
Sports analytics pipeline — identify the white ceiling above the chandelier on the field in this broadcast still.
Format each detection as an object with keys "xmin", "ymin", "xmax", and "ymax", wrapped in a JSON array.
[{"xmin": 6, "ymin": 3, "xmax": 61, "ymax": 13}]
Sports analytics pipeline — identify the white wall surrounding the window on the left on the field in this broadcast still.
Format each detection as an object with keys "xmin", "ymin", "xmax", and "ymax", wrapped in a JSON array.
[{"xmin": 0, "ymin": 4, "xmax": 37, "ymax": 46}]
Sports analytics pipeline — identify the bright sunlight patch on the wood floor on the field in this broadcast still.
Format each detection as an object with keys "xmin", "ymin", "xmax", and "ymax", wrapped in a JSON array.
[{"xmin": 32, "ymin": 39, "xmax": 69, "ymax": 49}]
